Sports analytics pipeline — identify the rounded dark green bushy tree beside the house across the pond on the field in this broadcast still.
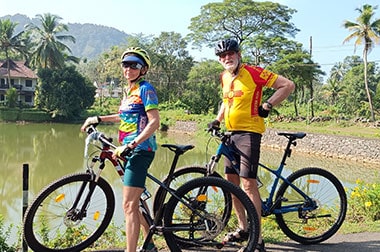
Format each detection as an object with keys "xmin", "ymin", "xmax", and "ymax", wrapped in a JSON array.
[{"xmin": 36, "ymin": 66, "xmax": 95, "ymax": 119}]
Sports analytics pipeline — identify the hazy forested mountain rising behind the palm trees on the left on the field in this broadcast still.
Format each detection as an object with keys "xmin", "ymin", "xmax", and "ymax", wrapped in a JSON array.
[{"xmin": 0, "ymin": 14, "xmax": 129, "ymax": 60}]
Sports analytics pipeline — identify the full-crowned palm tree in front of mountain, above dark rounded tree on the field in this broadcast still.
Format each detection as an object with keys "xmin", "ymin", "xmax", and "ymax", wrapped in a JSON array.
[{"xmin": 27, "ymin": 13, "xmax": 79, "ymax": 68}]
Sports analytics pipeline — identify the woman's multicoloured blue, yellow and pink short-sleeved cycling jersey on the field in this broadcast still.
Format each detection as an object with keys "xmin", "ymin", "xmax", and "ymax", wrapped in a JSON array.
[{"xmin": 119, "ymin": 80, "xmax": 158, "ymax": 151}]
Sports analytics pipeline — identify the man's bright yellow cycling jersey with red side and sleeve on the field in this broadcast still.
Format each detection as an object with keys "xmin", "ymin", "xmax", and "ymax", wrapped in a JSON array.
[{"xmin": 221, "ymin": 64, "xmax": 278, "ymax": 134}]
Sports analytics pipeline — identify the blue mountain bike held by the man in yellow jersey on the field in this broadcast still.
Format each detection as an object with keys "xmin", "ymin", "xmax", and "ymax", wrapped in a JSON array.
[{"xmin": 153, "ymin": 128, "xmax": 347, "ymax": 244}]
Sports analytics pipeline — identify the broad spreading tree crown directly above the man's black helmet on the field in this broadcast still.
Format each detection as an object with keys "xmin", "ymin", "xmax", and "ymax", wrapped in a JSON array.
[{"xmin": 188, "ymin": 0, "xmax": 298, "ymax": 49}]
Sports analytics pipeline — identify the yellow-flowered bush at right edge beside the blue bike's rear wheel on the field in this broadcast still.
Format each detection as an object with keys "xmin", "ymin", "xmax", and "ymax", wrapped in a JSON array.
[{"xmin": 347, "ymin": 180, "xmax": 380, "ymax": 223}]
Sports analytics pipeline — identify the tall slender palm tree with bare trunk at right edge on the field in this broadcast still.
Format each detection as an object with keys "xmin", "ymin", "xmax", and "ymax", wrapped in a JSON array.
[{"xmin": 343, "ymin": 4, "xmax": 380, "ymax": 121}]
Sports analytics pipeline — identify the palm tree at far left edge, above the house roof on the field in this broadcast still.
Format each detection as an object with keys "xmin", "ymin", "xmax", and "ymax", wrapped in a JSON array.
[{"xmin": 0, "ymin": 19, "xmax": 29, "ymax": 85}]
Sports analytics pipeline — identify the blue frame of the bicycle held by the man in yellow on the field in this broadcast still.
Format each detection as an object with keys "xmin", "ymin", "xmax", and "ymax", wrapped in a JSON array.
[{"xmin": 207, "ymin": 129, "xmax": 317, "ymax": 216}]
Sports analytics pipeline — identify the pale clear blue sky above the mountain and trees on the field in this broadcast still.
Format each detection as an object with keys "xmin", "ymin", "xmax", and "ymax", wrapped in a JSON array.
[{"xmin": 0, "ymin": 0, "xmax": 380, "ymax": 79}]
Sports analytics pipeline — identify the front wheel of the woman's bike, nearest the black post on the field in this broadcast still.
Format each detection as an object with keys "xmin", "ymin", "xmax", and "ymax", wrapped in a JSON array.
[{"xmin": 23, "ymin": 173, "xmax": 115, "ymax": 252}]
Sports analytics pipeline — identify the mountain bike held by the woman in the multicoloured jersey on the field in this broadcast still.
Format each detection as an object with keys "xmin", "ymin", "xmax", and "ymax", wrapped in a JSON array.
[{"xmin": 23, "ymin": 126, "xmax": 260, "ymax": 252}]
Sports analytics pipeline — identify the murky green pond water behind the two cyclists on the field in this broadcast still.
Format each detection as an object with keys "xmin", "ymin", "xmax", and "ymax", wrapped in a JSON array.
[{"xmin": 0, "ymin": 124, "xmax": 380, "ymax": 244}]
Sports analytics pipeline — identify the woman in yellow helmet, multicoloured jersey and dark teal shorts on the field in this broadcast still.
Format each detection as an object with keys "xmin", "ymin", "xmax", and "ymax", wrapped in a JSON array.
[{"xmin": 81, "ymin": 47, "xmax": 160, "ymax": 252}]
